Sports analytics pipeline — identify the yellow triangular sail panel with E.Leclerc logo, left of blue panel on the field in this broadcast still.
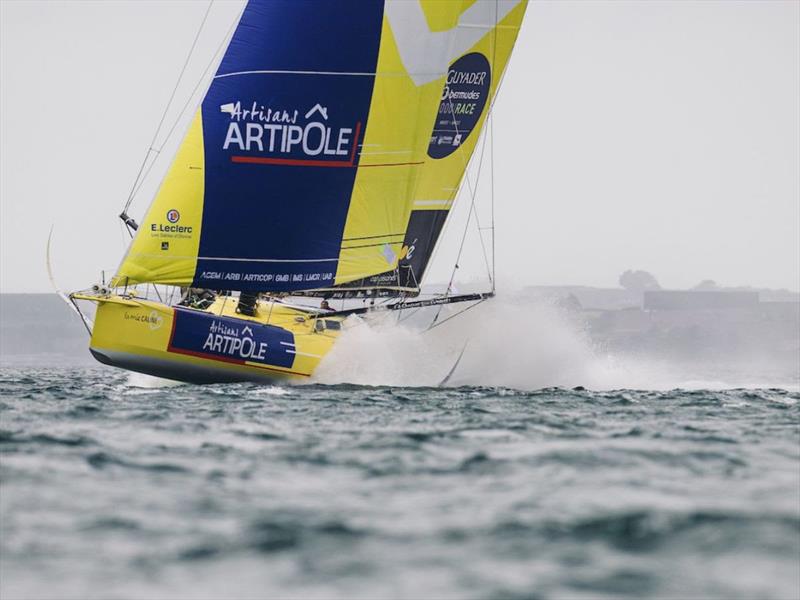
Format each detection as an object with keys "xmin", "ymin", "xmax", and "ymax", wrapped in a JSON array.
[{"xmin": 112, "ymin": 110, "xmax": 205, "ymax": 286}]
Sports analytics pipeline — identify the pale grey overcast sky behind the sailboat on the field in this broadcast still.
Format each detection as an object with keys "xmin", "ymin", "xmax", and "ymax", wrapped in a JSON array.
[{"xmin": 0, "ymin": 0, "xmax": 800, "ymax": 292}]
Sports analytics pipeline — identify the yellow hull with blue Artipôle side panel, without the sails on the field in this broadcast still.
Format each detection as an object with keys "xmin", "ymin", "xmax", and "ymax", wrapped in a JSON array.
[{"xmin": 78, "ymin": 296, "xmax": 339, "ymax": 383}]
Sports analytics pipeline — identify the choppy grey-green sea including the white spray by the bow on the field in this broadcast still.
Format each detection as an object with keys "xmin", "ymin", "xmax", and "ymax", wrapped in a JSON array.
[{"xmin": 0, "ymin": 302, "xmax": 800, "ymax": 600}]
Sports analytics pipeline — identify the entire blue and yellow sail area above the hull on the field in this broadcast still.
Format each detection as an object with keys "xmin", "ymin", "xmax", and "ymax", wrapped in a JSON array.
[{"xmin": 113, "ymin": 0, "xmax": 526, "ymax": 295}]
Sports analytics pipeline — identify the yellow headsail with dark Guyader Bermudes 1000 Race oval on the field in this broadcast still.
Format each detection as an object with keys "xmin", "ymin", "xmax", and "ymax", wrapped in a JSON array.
[{"xmin": 337, "ymin": 0, "xmax": 527, "ymax": 296}]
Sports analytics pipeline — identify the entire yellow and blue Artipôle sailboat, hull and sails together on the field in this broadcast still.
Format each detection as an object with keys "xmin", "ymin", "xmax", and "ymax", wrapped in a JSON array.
[{"xmin": 69, "ymin": 0, "xmax": 527, "ymax": 383}]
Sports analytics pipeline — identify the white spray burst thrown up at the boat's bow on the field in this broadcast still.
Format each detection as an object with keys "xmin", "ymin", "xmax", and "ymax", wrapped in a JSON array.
[{"xmin": 314, "ymin": 298, "xmax": 800, "ymax": 390}]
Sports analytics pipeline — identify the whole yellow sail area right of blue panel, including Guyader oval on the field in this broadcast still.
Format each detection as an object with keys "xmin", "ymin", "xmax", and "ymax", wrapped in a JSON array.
[{"xmin": 335, "ymin": 0, "xmax": 527, "ymax": 290}]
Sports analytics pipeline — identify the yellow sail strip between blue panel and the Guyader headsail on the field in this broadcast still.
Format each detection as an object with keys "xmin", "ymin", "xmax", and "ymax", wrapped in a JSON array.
[{"xmin": 335, "ymin": 0, "xmax": 484, "ymax": 285}]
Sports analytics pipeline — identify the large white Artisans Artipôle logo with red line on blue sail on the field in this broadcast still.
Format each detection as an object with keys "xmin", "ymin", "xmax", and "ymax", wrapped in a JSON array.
[{"xmin": 219, "ymin": 100, "xmax": 361, "ymax": 166}]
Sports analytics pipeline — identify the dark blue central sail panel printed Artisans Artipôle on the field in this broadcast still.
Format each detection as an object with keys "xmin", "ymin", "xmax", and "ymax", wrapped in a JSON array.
[{"xmin": 193, "ymin": 0, "xmax": 383, "ymax": 291}]
